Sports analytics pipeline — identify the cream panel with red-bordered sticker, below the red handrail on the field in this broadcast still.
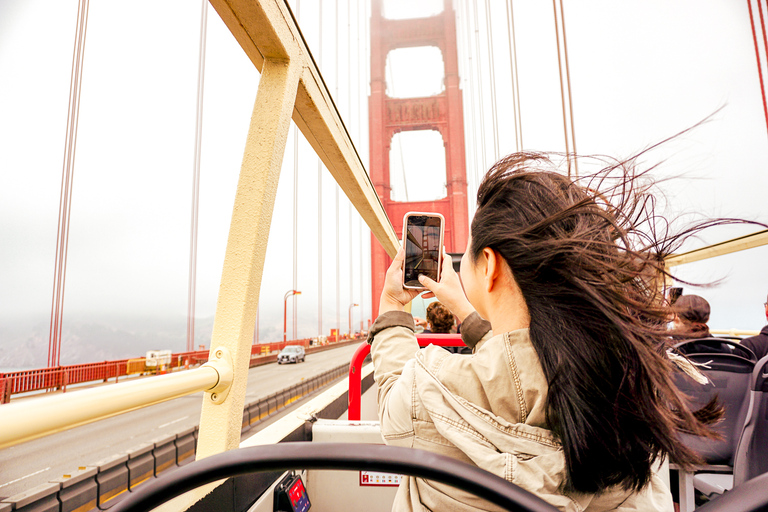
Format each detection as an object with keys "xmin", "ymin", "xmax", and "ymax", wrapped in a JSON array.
[{"xmin": 306, "ymin": 419, "xmax": 400, "ymax": 512}]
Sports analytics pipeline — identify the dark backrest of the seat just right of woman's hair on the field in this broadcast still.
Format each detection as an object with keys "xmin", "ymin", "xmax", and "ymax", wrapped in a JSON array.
[{"xmin": 675, "ymin": 338, "xmax": 756, "ymax": 466}]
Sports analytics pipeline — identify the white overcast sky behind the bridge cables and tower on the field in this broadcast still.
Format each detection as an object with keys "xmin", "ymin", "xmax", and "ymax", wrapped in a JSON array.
[{"xmin": 0, "ymin": 0, "xmax": 768, "ymax": 364}]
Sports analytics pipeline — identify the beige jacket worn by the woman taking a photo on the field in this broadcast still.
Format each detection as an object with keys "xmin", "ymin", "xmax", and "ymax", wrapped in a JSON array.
[{"xmin": 371, "ymin": 312, "xmax": 673, "ymax": 512}]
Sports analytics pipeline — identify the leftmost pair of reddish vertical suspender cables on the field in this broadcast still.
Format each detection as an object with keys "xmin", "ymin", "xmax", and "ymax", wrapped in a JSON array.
[{"xmin": 48, "ymin": 0, "xmax": 90, "ymax": 367}]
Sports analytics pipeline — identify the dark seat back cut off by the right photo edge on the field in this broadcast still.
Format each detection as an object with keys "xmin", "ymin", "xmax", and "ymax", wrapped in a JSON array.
[{"xmin": 733, "ymin": 356, "xmax": 768, "ymax": 485}]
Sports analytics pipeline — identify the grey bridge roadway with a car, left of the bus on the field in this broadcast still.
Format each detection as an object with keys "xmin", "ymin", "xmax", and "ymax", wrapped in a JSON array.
[{"xmin": 0, "ymin": 344, "xmax": 364, "ymax": 499}]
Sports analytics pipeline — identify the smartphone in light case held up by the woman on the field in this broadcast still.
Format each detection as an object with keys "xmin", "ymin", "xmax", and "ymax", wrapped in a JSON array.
[{"xmin": 403, "ymin": 212, "xmax": 445, "ymax": 290}]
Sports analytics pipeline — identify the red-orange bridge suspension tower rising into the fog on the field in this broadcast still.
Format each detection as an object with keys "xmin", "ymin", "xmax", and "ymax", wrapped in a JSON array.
[{"xmin": 369, "ymin": 0, "xmax": 469, "ymax": 318}]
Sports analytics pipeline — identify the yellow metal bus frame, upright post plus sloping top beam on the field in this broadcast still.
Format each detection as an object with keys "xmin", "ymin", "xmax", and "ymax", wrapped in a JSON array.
[{"xmin": 197, "ymin": 0, "xmax": 398, "ymax": 458}]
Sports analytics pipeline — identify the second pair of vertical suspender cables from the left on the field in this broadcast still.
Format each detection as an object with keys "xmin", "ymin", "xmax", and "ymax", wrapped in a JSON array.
[{"xmin": 187, "ymin": 0, "xmax": 208, "ymax": 352}]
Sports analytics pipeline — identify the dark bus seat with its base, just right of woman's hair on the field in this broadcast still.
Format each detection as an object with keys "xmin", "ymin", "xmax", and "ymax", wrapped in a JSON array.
[{"xmin": 673, "ymin": 338, "xmax": 756, "ymax": 512}]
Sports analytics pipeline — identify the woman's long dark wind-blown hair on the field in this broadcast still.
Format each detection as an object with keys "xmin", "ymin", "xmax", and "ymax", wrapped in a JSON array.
[{"xmin": 469, "ymin": 153, "xmax": 760, "ymax": 493}]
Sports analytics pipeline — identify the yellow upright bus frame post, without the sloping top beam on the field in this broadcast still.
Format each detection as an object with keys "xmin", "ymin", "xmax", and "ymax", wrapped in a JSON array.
[{"xmin": 197, "ymin": 58, "xmax": 301, "ymax": 459}]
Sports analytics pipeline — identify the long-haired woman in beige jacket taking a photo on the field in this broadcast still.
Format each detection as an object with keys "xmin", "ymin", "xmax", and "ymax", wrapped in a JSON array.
[{"xmin": 369, "ymin": 153, "xmax": 732, "ymax": 512}]
